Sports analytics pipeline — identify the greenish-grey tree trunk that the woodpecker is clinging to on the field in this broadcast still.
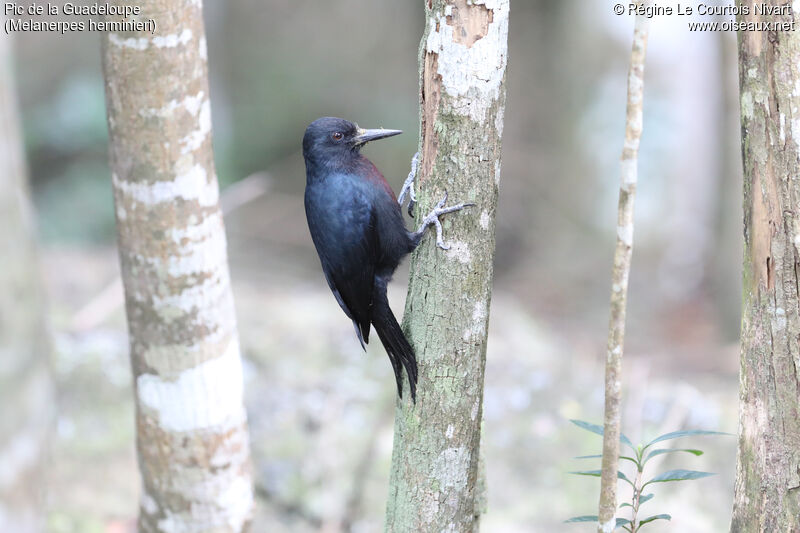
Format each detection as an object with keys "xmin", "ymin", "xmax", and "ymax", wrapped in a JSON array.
[{"xmin": 386, "ymin": 0, "xmax": 509, "ymax": 533}]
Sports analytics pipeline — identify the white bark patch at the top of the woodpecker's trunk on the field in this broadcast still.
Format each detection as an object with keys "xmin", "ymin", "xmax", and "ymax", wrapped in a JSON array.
[{"xmin": 425, "ymin": 0, "xmax": 509, "ymax": 122}]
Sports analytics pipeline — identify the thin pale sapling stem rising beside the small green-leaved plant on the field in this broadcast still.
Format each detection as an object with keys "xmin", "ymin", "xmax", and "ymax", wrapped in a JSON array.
[{"xmin": 597, "ymin": 6, "xmax": 649, "ymax": 533}]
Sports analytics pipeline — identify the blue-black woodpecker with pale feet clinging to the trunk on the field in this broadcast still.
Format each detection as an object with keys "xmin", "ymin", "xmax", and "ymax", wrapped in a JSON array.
[{"xmin": 303, "ymin": 117, "xmax": 473, "ymax": 401}]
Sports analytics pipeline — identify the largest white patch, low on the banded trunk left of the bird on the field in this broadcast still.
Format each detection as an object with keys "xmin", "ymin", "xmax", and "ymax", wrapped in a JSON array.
[{"xmin": 136, "ymin": 338, "xmax": 245, "ymax": 431}]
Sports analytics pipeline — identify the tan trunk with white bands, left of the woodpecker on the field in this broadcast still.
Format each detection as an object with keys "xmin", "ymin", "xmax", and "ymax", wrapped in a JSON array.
[{"xmin": 103, "ymin": 0, "xmax": 253, "ymax": 533}]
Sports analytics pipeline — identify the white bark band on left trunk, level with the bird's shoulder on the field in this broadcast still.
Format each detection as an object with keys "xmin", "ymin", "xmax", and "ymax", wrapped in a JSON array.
[{"xmin": 111, "ymin": 160, "xmax": 219, "ymax": 207}]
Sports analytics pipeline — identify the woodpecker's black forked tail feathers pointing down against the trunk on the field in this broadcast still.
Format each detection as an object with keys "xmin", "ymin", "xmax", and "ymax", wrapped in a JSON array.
[{"xmin": 372, "ymin": 287, "xmax": 417, "ymax": 403}]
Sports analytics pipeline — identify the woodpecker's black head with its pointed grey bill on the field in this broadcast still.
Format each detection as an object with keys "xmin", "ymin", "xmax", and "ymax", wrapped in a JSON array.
[{"xmin": 303, "ymin": 117, "xmax": 403, "ymax": 163}]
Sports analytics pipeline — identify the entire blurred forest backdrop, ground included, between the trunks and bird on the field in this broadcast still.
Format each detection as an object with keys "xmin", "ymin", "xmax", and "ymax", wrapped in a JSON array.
[{"xmin": 9, "ymin": 0, "xmax": 741, "ymax": 533}]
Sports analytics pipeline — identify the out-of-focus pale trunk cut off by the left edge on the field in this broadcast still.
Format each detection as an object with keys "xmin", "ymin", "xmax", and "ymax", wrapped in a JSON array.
[{"xmin": 0, "ymin": 16, "xmax": 54, "ymax": 533}]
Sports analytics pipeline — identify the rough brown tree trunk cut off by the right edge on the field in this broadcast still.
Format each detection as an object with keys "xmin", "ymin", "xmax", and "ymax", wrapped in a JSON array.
[{"xmin": 731, "ymin": 0, "xmax": 800, "ymax": 533}]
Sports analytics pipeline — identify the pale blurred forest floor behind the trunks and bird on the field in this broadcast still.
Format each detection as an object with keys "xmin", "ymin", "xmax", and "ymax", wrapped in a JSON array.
[{"xmin": 43, "ymin": 192, "xmax": 738, "ymax": 533}]
